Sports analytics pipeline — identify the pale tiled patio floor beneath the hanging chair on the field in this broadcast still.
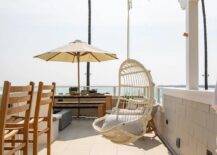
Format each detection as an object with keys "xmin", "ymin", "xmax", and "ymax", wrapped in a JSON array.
[{"xmin": 39, "ymin": 118, "xmax": 170, "ymax": 155}]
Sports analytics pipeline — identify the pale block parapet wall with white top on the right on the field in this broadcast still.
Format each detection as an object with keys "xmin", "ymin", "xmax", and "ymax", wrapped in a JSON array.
[{"xmin": 155, "ymin": 89, "xmax": 217, "ymax": 155}]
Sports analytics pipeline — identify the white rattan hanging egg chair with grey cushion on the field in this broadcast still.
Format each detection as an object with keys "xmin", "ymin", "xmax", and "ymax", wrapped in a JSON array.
[{"xmin": 93, "ymin": 59, "xmax": 155, "ymax": 144}]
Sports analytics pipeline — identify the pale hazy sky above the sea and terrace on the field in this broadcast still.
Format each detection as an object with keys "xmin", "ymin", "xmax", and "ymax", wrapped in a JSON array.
[{"xmin": 0, "ymin": 0, "xmax": 217, "ymax": 86}]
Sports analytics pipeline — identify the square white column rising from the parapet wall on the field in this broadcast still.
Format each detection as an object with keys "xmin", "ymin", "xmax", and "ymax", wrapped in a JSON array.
[{"xmin": 186, "ymin": 0, "xmax": 199, "ymax": 90}]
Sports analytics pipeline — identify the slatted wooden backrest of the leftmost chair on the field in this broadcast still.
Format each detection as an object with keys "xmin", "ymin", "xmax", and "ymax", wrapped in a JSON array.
[{"xmin": 0, "ymin": 81, "xmax": 34, "ymax": 153}]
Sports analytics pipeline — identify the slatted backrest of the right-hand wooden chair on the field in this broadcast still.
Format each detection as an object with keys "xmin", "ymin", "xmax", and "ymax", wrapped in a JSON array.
[{"xmin": 34, "ymin": 82, "xmax": 56, "ymax": 126}]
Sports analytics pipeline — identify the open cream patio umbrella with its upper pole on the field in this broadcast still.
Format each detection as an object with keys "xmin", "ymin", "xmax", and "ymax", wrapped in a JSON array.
[{"xmin": 34, "ymin": 40, "xmax": 117, "ymax": 92}]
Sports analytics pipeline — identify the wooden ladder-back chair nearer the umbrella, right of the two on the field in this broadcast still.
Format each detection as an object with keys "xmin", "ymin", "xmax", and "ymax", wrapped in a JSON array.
[{"xmin": 30, "ymin": 82, "xmax": 56, "ymax": 155}]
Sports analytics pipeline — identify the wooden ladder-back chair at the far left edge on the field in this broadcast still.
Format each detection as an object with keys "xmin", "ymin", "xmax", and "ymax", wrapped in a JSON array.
[{"xmin": 0, "ymin": 81, "xmax": 34, "ymax": 155}]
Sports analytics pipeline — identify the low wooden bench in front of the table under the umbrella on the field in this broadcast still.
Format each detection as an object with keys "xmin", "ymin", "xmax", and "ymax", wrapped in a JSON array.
[{"xmin": 53, "ymin": 95, "xmax": 112, "ymax": 117}]
